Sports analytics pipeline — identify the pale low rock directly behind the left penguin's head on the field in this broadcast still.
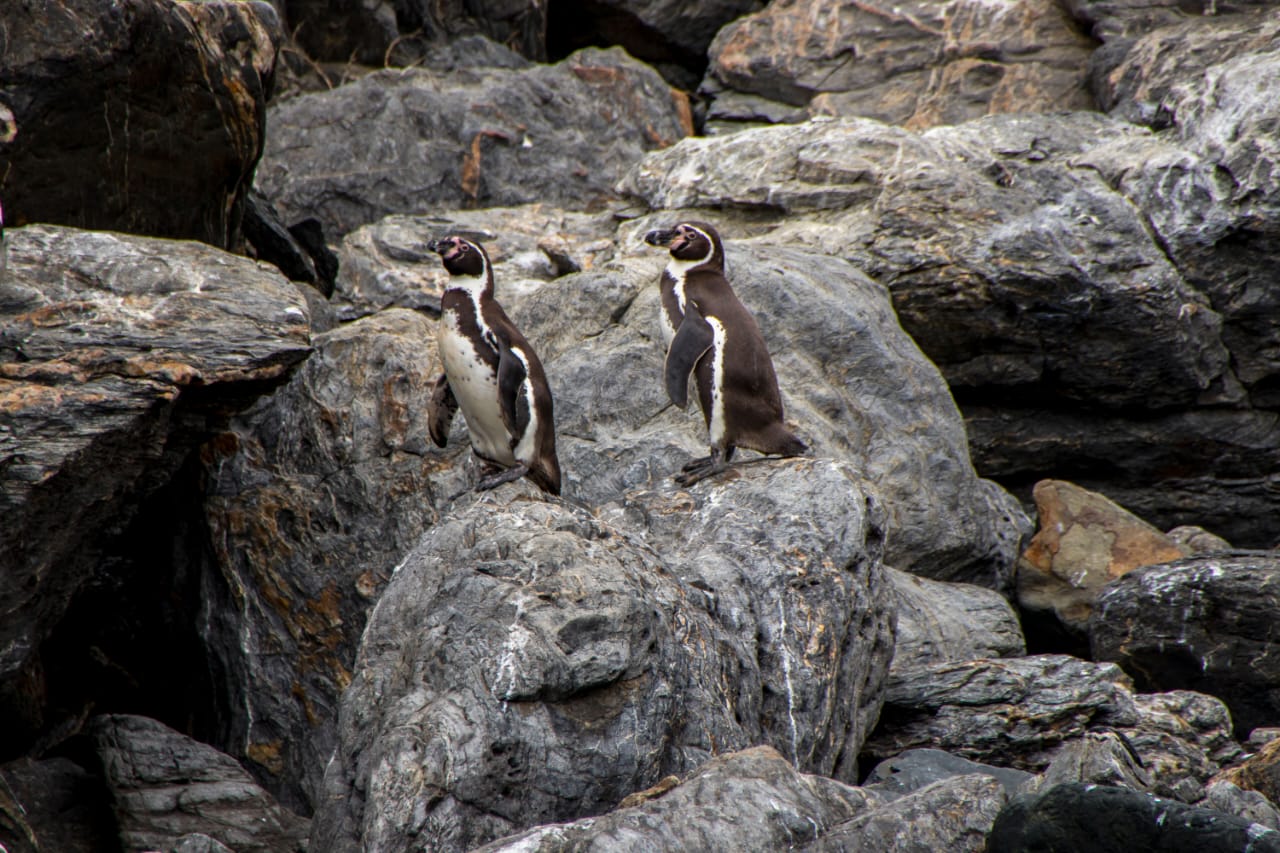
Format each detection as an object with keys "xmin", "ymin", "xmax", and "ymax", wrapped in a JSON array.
[{"xmin": 333, "ymin": 204, "xmax": 625, "ymax": 322}]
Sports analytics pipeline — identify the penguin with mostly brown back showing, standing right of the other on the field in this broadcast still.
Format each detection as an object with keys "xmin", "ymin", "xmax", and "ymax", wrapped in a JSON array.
[{"xmin": 644, "ymin": 222, "xmax": 808, "ymax": 487}]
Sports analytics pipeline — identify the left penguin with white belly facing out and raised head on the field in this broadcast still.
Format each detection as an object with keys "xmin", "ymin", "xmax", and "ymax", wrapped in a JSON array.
[{"xmin": 428, "ymin": 237, "xmax": 561, "ymax": 494}]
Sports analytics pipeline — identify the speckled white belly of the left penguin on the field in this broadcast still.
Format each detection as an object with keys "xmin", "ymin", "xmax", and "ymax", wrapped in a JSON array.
[{"xmin": 438, "ymin": 311, "xmax": 516, "ymax": 466}]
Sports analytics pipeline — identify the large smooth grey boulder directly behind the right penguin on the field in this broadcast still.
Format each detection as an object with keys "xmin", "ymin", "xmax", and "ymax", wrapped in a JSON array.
[{"xmin": 555, "ymin": 239, "xmax": 1030, "ymax": 588}]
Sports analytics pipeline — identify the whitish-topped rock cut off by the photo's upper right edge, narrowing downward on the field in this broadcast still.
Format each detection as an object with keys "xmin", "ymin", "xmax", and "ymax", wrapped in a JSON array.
[{"xmin": 1088, "ymin": 27, "xmax": 1280, "ymax": 409}]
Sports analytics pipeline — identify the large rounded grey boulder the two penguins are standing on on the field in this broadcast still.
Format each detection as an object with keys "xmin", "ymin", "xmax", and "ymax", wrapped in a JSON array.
[{"xmin": 311, "ymin": 461, "xmax": 892, "ymax": 850}]
